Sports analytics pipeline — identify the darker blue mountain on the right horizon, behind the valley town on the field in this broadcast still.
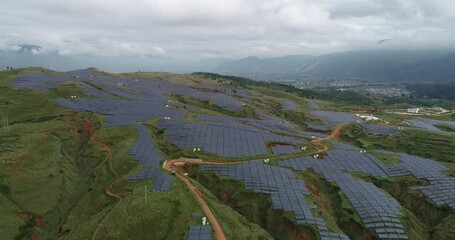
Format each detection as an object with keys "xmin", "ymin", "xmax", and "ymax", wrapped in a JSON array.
[{"xmin": 214, "ymin": 50, "xmax": 455, "ymax": 81}]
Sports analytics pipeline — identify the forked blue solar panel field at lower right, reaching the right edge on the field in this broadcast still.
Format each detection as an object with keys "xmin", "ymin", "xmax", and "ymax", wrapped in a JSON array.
[{"xmin": 279, "ymin": 144, "xmax": 455, "ymax": 239}]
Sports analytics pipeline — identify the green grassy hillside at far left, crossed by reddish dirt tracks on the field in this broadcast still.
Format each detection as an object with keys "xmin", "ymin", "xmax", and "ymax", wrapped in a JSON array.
[{"xmin": 0, "ymin": 70, "xmax": 145, "ymax": 239}]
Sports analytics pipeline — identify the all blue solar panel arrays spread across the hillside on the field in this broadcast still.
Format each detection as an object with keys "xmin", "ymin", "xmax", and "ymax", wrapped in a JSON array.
[{"xmin": 13, "ymin": 70, "xmax": 455, "ymax": 239}]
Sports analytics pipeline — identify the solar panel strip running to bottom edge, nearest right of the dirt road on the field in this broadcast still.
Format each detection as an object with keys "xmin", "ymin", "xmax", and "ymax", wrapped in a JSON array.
[{"xmin": 199, "ymin": 161, "xmax": 349, "ymax": 239}]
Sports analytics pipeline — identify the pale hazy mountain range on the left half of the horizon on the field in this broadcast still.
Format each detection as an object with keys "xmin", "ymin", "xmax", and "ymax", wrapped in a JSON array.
[{"xmin": 0, "ymin": 44, "xmax": 232, "ymax": 73}]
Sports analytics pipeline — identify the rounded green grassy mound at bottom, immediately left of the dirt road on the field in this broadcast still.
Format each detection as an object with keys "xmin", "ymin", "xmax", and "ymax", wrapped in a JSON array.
[{"xmin": 91, "ymin": 180, "xmax": 201, "ymax": 239}]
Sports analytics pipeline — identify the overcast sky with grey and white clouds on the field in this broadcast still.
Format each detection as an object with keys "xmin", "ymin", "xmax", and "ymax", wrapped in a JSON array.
[{"xmin": 0, "ymin": 0, "xmax": 455, "ymax": 59}]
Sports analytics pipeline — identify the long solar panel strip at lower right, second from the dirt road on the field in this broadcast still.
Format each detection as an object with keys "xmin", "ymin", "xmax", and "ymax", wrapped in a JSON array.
[{"xmin": 279, "ymin": 144, "xmax": 407, "ymax": 239}]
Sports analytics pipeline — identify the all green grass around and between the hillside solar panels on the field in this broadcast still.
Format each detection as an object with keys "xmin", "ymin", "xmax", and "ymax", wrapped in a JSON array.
[{"xmin": 0, "ymin": 68, "xmax": 455, "ymax": 239}]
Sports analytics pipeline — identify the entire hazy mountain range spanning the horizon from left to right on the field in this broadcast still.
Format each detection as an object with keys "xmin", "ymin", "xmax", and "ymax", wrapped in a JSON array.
[{"xmin": 0, "ymin": 44, "xmax": 455, "ymax": 82}]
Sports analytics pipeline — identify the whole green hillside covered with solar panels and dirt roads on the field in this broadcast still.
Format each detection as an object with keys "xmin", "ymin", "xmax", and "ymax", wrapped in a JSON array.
[{"xmin": 0, "ymin": 68, "xmax": 455, "ymax": 239}]
